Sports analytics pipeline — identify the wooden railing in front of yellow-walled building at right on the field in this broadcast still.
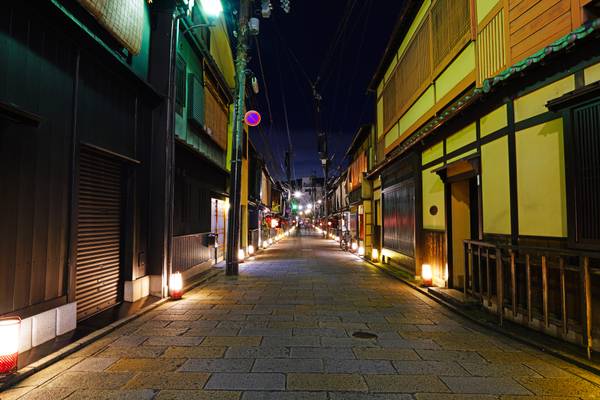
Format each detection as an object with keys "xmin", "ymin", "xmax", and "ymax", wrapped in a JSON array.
[{"xmin": 464, "ymin": 240, "xmax": 600, "ymax": 357}]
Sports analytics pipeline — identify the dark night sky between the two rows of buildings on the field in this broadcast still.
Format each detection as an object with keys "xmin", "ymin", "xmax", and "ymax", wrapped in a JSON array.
[{"xmin": 250, "ymin": 0, "xmax": 402, "ymax": 179}]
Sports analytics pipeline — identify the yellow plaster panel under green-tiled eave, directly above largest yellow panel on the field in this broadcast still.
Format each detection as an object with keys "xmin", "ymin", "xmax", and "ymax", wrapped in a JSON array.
[{"xmin": 515, "ymin": 75, "xmax": 575, "ymax": 122}]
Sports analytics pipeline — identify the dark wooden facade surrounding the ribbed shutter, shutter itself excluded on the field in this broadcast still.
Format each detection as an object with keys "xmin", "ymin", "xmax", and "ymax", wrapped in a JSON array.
[{"xmin": 0, "ymin": 1, "xmax": 160, "ymax": 317}]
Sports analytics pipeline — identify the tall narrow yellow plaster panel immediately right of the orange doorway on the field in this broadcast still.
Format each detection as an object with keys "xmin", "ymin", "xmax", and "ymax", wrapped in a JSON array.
[{"xmin": 481, "ymin": 136, "xmax": 510, "ymax": 234}]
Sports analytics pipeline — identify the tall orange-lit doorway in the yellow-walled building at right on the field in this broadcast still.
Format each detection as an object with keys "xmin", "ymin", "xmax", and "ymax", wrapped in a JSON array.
[{"xmin": 448, "ymin": 176, "xmax": 479, "ymax": 290}]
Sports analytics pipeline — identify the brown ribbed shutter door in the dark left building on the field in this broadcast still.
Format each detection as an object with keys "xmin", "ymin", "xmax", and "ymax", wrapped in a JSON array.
[{"xmin": 76, "ymin": 149, "xmax": 122, "ymax": 320}]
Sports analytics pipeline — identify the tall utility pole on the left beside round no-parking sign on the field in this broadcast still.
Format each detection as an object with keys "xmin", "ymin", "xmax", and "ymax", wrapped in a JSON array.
[{"xmin": 225, "ymin": 0, "xmax": 250, "ymax": 275}]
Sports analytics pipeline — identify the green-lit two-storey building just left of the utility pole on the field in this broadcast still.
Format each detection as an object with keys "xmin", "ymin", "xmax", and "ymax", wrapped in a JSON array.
[{"xmin": 172, "ymin": 4, "xmax": 235, "ymax": 279}]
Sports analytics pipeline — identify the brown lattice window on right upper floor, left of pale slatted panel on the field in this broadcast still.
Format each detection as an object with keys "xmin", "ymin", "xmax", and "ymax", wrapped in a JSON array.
[{"xmin": 431, "ymin": 0, "xmax": 471, "ymax": 66}]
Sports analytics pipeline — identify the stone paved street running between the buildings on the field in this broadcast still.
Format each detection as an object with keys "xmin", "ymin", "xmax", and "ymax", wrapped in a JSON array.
[{"xmin": 0, "ymin": 231, "xmax": 600, "ymax": 400}]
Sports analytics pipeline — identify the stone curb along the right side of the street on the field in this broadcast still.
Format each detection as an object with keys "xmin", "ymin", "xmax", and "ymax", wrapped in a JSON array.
[{"xmin": 360, "ymin": 253, "xmax": 600, "ymax": 380}]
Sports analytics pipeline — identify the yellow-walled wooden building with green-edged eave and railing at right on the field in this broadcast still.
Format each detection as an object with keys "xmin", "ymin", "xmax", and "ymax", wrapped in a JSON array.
[{"xmin": 369, "ymin": 0, "xmax": 600, "ymax": 351}]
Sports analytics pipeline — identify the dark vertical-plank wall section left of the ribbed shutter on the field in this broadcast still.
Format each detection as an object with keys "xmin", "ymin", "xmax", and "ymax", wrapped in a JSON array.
[{"xmin": 0, "ymin": 6, "xmax": 75, "ymax": 315}]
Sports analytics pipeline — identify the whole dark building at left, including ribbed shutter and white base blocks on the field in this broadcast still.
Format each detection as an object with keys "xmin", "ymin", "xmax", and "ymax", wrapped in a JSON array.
[{"xmin": 0, "ymin": 0, "xmax": 159, "ymax": 359}]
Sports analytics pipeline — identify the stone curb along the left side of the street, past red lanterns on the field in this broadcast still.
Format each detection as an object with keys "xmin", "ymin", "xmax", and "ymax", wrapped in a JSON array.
[{"xmin": 0, "ymin": 268, "xmax": 223, "ymax": 392}]
